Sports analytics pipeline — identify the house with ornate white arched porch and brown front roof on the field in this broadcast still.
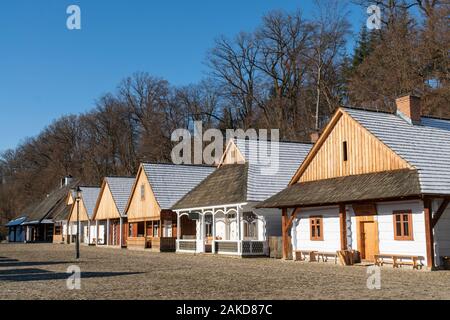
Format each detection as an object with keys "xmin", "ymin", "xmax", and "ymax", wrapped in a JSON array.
[{"xmin": 173, "ymin": 139, "xmax": 312, "ymax": 256}]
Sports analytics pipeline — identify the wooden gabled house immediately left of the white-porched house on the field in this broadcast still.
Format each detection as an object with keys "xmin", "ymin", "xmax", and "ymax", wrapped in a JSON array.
[{"xmin": 125, "ymin": 163, "xmax": 214, "ymax": 251}]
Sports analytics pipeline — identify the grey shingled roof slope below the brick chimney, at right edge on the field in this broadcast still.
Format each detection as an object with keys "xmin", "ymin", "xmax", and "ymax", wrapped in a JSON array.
[{"xmin": 343, "ymin": 108, "xmax": 450, "ymax": 195}]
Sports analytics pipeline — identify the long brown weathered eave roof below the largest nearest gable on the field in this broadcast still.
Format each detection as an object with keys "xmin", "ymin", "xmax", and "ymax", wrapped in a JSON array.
[{"xmin": 258, "ymin": 169, "xmax": 421, "ymax": 208}]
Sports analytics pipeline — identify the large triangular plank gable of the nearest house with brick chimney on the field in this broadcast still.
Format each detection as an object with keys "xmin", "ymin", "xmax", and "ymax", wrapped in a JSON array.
[{"xmin": 290, "ymin": 109, "xmax": 413, "ymax": 185}]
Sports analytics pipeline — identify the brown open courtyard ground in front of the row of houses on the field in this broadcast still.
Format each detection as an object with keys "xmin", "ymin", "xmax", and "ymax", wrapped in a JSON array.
[{"xmin": 0, "ymin": 244, "xmax": 450, "ymax": 300}]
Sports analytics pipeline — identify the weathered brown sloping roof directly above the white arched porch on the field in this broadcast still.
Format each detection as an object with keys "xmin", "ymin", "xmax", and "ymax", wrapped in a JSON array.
[{"xmin": 172, "ymin": 164, "xmax": 248, "ymax": 210}]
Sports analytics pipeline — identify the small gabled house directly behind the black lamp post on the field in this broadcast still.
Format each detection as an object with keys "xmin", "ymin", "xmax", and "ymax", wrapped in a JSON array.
[{"xmin": 68, "ymin": 187, "xmax": 100, "ymax": 245}]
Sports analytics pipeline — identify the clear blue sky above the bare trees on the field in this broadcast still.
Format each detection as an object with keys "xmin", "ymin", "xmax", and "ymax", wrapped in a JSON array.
[{"xmin": 0, "ymin": 0, "xmax": 365, "ymax": 151}]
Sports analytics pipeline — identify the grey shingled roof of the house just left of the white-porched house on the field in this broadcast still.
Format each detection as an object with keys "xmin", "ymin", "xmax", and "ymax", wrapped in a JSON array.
[{"xmin": 142, "ymin": 163, "xmax": 215, "ymax": 210}]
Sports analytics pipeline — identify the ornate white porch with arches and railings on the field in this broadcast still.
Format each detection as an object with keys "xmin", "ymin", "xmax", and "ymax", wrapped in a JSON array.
[{"xmin": 176, "ymin": 203, "xmax": 268, "ymax": 256}]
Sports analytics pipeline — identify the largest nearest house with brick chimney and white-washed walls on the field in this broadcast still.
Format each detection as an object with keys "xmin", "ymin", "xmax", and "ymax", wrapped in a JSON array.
[{"xmin": 260, "ymin": 96, "xmax": 450, "ymax": 268}]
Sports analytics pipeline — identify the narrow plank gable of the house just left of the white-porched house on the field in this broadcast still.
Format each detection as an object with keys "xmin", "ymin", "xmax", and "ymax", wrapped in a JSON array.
[{"xmin": 125, "ymin": 165, "xmax": 162, "ymax": 222}]
